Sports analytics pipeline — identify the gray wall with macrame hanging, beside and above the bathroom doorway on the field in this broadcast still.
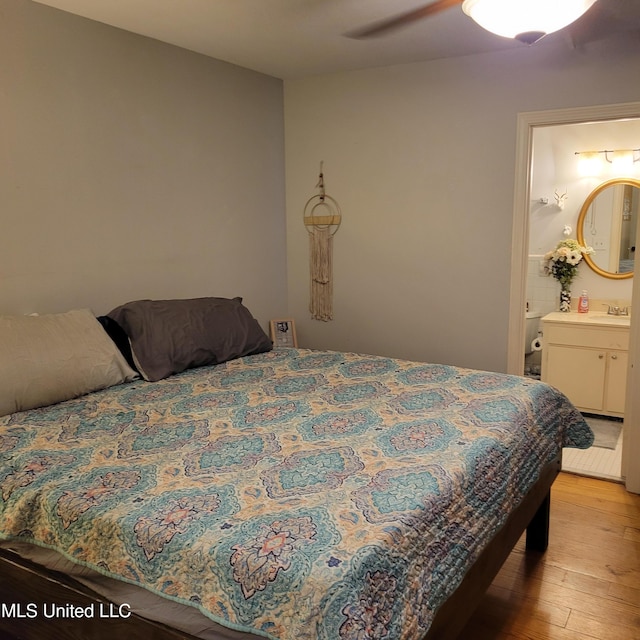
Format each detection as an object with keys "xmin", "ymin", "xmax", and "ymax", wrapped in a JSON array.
[{"xmin": 285, "ymin": 37, "xmax": 640, "ymax": 371}]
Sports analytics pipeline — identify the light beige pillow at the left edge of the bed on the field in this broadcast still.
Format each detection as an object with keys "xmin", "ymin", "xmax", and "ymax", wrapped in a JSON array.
[{"xmin": 0, "ymin": 309, "xmax": 138, "ymax": 416}]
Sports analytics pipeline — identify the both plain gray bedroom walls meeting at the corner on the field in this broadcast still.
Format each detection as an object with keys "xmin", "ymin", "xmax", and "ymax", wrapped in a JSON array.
[{"xmin": 5, "ymin": 0, "xmax": 640, "ymax": 370}]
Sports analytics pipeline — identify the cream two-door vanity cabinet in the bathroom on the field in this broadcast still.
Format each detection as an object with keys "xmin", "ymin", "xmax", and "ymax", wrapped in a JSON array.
[{"xmin": 542, "ymin": 312, "xmax": 630, "ymax": 417}]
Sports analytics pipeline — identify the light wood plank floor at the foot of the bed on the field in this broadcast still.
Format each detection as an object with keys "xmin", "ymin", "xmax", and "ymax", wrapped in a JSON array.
[{"xmin": 460, "ymin": 473, "xmax": 640, "ymax": 640}]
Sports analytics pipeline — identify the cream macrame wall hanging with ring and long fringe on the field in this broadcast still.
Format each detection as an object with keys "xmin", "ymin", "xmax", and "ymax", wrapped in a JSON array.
[{"xmin": 304, "ymin": 162, "xmax": 342, "ymax": 322}]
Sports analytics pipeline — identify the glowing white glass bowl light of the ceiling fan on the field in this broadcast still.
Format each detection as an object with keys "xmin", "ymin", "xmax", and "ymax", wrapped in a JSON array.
[{"xmin": 462, "ymin": 0, "xmax": 596, "ymax": 44}]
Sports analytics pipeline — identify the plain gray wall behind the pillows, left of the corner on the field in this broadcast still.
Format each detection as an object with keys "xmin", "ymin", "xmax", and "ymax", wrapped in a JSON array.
[{"xmin": 0, "ymin": 0, "xmax": 287, "ymax": 327}]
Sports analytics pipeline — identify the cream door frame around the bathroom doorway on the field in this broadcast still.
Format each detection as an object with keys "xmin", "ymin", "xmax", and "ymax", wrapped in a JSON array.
[{"xmin": 507, "ymin": 102, "xmax": 640, "ymax": 493}]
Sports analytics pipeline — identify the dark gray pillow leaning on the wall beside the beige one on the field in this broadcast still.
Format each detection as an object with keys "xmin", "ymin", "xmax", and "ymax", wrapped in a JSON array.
[{"xmin": 107, "ymin": 298, "xmax": 273, "ymax": 382}]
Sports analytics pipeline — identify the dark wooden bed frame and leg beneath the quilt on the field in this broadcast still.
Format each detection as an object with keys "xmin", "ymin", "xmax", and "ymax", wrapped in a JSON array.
[{"xmin": 0, "ymin": 451, "xmax": 562, "ymax": 640}]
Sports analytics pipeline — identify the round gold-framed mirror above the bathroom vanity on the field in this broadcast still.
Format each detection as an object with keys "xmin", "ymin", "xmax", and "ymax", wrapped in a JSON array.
[{"xmin": 577, "ymin": 178, "xmax": 640, "ymax": 279}]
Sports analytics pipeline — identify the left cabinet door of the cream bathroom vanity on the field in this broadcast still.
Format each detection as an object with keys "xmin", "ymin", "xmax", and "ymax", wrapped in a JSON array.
[{"xmin": 545, "ymin": 344, "xmax": 607, "ymax": 411}]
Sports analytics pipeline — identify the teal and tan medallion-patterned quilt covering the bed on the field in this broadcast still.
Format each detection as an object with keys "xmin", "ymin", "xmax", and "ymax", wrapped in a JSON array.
[{"xmin": 0, "ymin": 349, "xmax": 593, "ymax": 640}]
